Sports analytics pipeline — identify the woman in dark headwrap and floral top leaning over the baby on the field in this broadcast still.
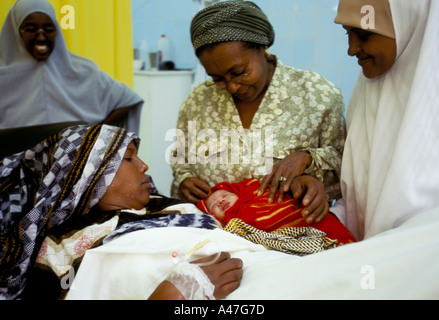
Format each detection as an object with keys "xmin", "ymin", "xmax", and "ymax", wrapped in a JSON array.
[{"xmin": 171, "ymin": 1, "xmax": 345, "ymax": 222}]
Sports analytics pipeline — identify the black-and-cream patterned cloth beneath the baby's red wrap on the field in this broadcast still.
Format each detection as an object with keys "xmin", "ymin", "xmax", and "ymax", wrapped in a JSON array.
[{"xmin": 224, "ymin": 218, "xmax": 339, "ymax": 256}]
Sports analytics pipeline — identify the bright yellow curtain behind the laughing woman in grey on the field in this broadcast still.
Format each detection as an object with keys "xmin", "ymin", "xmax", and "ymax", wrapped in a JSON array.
[{"xmin": 0, "ymin": 0, "xmax": 133, "ymax": 87}]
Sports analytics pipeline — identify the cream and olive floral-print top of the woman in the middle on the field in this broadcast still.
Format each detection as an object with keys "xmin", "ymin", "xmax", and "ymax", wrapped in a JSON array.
[{"xmin": 170, "ymin": 59, "xmax": 346, "ymax": 201}]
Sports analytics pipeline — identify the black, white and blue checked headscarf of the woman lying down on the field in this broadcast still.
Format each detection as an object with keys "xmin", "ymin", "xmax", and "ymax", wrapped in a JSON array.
[{"xmin": 0, "ymin": 125, "xmax": 138, "ymax": 299}]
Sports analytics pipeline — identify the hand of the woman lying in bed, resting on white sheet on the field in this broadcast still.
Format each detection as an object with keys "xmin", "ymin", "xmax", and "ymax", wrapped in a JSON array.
[{"xmin": 199, "ymin": 252, "xmax": 243, "ymax": 300}]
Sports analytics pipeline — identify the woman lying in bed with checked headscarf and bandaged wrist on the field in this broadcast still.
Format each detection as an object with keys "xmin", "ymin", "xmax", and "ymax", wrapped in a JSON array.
[{"xmin": 0, "ymin": 125, "xmax": 242, "ymax": 299}]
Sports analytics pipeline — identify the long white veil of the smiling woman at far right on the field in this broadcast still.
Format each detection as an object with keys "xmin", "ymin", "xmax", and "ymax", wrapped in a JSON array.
[{"xmin": 341, "ymin": 0, "xmax": 439, "ymax": 239}]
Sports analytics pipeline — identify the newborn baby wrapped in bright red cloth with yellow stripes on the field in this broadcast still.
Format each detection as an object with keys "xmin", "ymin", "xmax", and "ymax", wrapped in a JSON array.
[{"xmin": 197, "ymin": 179, "xmax": 357, "ymax": 244}]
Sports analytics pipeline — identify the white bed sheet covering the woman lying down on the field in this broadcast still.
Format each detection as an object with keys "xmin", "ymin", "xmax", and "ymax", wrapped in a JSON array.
[{"xmin": 67, "ymin": 210, "xmax": 439, "ymax": 300}]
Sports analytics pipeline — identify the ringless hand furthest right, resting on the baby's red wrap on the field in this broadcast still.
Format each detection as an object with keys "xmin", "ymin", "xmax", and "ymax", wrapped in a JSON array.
[{"xmin": 291, "ymin": 175, "xmax": 329, "ymax": 223}]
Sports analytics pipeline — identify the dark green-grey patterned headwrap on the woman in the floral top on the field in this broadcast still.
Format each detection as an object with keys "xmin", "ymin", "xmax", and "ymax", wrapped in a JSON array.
[{"xmin": 191, "ymin": 1, "xmax": 274, "ymax": 51}]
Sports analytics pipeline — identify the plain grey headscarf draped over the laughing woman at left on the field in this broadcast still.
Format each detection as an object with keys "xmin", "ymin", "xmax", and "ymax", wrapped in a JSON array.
[{"xmin": 0, "ymin": 0, "xmax": 143, "ymax": 132}]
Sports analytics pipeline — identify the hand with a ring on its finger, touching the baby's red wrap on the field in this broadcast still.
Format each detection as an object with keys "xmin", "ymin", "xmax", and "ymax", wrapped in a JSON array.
[{"xmin": 259, "ymin": 152, "xmax": 312, "ymax": 203}]
